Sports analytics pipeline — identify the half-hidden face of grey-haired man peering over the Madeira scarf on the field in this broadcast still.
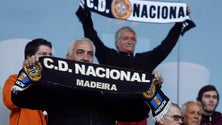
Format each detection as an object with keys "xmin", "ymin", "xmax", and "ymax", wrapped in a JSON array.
[{"xmin": 67, "ymin": 40, "xmax": 94, "ymax": 63}]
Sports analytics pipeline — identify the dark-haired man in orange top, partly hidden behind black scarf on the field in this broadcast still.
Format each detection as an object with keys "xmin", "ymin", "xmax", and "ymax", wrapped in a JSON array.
[{"xmin": 2, "ymin": 38, "xmax": 52, "ymax": 125}]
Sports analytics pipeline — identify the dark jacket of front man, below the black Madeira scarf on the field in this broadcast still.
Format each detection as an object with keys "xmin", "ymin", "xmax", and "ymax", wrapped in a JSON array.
[{"xmin": 12, "ymin": 83, "xmax": 115, "ymax": 125}]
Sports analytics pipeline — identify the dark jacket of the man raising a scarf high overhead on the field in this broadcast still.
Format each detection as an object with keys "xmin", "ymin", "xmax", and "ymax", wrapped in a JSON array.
[{"xmin": 80, "ymin": 10, "xmax": 182, "ymax": 121}]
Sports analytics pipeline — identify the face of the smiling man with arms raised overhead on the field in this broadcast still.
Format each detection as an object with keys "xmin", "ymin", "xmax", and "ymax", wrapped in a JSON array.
[{"xmin": 117, "ymin": 31, "xmax": 136, "ymax": 53}]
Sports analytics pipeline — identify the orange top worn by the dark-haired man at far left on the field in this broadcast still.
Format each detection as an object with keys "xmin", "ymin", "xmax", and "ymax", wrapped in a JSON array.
[{"xmin": 3, "ymin": 74, "xmax": 46, "ymax": 125}]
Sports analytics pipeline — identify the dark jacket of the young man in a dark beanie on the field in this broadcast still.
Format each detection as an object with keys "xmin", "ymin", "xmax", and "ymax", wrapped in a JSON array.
[{"xmin": 200, "ymin": 112, "xmax": 222, "ymax": 125}]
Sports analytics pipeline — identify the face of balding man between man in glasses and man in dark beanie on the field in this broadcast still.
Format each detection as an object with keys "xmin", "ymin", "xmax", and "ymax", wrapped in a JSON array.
[{"xmin": 183, "ymin": 102, "xmax": 202, "ymax": 125}]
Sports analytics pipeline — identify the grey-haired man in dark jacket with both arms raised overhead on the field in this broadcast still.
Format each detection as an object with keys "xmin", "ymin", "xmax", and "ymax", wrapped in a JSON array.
[{"xmin": 76, "ymin": 0, "xmax": 193, "ymax": 125}]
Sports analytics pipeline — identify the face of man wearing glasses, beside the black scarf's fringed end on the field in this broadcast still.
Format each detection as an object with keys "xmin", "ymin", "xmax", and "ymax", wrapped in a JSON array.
[{"xmin": 160, "ymin": 107, "xmax": 182, "ymax": 125}]
